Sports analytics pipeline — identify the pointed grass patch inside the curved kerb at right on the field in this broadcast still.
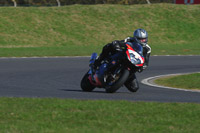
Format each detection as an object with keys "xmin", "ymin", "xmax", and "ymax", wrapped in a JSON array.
[{"xmin": 155, "ymin": 73, "xmax": 200, "ymax": 90}]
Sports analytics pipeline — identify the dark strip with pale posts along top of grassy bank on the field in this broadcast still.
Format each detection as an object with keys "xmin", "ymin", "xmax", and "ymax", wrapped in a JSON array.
[{"xmin": 0, "ymin": 0, "xmax": 174, "ymax": 6}]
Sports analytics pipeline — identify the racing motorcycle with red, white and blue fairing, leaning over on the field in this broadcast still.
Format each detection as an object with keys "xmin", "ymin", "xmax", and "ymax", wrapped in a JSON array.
[{"xmin": 81, "ymin": 42, "xmax": 144, "ymax": 93}]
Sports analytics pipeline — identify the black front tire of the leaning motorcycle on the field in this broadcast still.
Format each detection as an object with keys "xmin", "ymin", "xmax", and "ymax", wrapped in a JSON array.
[{"xmin": 106, "ymin": 69, "xmax": 129, "ymax": 93}]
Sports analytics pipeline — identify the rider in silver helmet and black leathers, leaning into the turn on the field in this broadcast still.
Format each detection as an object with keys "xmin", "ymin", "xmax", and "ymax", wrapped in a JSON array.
[{"xmin": 92, "ymin": 29, "xmax": 151, "ymax": 92}]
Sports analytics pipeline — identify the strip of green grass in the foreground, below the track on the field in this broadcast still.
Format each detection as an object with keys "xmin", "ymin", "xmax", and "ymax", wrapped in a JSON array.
[{"xmin": 0, "ymin": 98, "xmax": 200, "ymax": 133}]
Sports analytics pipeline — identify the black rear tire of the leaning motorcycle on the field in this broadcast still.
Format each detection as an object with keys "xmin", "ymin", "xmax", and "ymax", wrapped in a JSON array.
[{"xmin": 81, "ymin": 73, "xmax": 95, "ymax": 92}]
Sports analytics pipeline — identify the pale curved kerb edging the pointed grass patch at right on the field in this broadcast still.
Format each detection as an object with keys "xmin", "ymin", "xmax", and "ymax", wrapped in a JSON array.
[{"xmin": 141, "ymin": 72, "xmax": 200, "ymax": 93}]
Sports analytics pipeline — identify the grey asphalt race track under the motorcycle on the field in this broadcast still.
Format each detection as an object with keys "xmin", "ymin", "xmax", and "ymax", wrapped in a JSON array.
[{"xmin": 0, "ymin": 56, "xmax": 200, "ymax": 103}]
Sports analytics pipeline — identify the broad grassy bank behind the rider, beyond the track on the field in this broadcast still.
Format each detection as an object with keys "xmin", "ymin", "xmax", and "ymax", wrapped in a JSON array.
[{"xmin": 0, "ymin": 4, "xmax": 200, "ymax": 57}]
